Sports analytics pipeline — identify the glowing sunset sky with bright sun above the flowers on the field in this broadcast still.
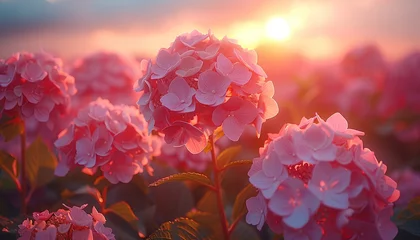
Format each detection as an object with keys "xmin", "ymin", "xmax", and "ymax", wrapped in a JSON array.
[{"xmin": 0, "ymin": 0, "xmax": 420, "ymax": 59}]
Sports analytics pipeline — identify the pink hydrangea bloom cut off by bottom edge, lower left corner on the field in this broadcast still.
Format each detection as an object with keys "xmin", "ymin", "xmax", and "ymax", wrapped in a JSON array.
[{"xmin": 18, "ymin": 204, "xmax": 115, "ymax": 240}]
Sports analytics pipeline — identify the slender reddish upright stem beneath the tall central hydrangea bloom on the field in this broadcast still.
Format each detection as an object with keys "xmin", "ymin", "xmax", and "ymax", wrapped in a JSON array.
[{"xmin": 209, "ymin": 135, "xmax": 229, "ymax": 240}]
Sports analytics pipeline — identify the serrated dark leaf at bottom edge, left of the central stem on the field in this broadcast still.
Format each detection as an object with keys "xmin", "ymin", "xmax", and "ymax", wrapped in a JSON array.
[{"xmin": 148, "ymin": 218, "xmax": 211, "ymax": 240}]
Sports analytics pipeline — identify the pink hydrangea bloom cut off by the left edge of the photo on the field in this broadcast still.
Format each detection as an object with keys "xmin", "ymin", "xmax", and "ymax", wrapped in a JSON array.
[{"xmin": 0, "ymin": 52, "xmax": 76, "ymax": 125}]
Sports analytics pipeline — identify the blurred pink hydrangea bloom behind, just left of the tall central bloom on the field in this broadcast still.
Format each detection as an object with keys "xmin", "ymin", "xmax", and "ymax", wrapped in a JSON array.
[{"xmin": 70, "ymin": 52, "xmax": 139, "ymax": 107}]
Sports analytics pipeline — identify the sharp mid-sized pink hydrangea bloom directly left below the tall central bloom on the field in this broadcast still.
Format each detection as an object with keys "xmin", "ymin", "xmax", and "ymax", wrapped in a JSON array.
[{"xmin": 54, "ymin": 98, "xmax": 155, "ymax": 183}]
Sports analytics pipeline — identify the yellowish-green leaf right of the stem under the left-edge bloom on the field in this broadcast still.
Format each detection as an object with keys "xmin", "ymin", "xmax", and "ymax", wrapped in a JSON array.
[{"xmin": 25, "ymin": 137, "xmax": 57, "ymax": 187}]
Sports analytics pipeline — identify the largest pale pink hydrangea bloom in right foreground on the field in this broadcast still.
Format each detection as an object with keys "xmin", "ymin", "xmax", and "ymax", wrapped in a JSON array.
[{"xmin": 246, "ymin": 113, "xmax": 399, "ymax": 240}]
